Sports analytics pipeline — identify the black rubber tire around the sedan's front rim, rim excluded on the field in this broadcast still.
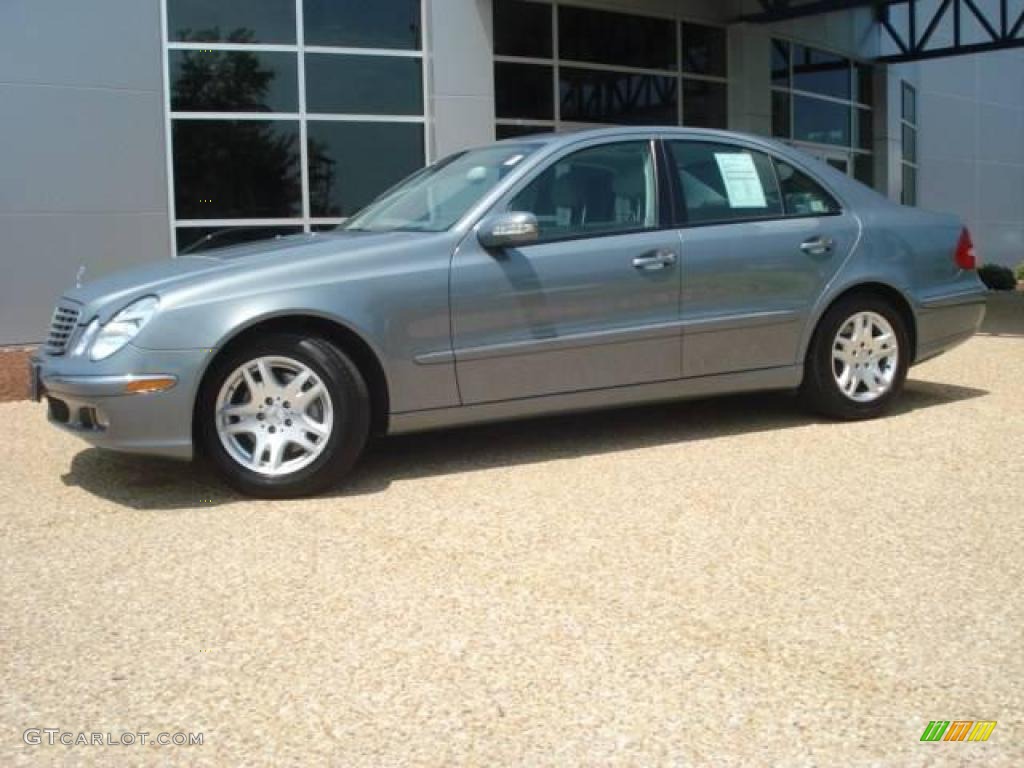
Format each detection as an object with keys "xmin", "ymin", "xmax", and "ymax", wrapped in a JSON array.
[{"xmin": 197, "ymin": 333, "xmax": 371, "ymax": 499}]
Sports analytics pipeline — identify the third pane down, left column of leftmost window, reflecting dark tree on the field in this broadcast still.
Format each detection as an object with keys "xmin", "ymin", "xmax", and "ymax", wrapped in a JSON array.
[{"xmin": 172, "ymin": 120, "xmax": 302, "ymax": 219}]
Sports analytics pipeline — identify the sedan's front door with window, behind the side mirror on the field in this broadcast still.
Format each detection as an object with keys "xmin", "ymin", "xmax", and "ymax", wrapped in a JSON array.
[{"xmin": 452, "ymin": 140, "xmax": 682, "ymax": 404}]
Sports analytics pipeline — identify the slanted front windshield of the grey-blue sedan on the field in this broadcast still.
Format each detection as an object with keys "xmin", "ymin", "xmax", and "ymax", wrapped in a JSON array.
[{"xmin": 341, "ymin": 143, "xmax": 540, "ymax": 232}]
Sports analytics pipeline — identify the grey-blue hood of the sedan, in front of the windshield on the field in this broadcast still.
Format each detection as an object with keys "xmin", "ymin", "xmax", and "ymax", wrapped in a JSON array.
[{"xmin": 65, "ymin": 230, "xmax": 436, "ymax": 323}]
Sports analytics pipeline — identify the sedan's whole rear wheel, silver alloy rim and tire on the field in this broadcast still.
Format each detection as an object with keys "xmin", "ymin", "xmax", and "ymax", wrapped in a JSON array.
[{"xmin": 801, "ymin": 295, "xmax": 910, "ymax": 419}]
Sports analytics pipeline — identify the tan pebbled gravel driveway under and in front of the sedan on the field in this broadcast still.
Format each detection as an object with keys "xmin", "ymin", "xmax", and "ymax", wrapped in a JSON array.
[{"xmin": 0, "ymin": 296, "xmax": 1024, "ymax": 766}]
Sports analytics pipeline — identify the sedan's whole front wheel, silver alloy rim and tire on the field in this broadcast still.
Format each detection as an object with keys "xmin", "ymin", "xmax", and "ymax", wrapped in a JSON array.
[{"xmin": 199, "ymin": 334, "xmax": 370, "ymax": 499}]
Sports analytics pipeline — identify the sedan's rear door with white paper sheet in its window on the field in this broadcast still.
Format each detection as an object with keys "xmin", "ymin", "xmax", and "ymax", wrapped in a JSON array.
[{"xmin": 667, "ymin": 140, "xmax": 859, "ymax": 377}]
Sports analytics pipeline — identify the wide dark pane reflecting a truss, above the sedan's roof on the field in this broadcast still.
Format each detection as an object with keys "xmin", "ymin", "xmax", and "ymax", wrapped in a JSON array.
[{"xmin": 559, "ymin": 68, "xmax": 679, "ymax": 125}]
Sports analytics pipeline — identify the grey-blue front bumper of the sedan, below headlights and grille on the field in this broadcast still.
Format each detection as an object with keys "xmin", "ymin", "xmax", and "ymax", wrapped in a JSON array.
[{"xmin": 31, "ymin": 345, "xmax": 210, "ymax": 460}]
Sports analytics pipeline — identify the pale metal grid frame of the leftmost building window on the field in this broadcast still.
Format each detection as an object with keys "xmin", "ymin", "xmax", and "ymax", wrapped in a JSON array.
[{"xmin": 160, "ymin": 0, "xmax": 434, "ymax": 258}]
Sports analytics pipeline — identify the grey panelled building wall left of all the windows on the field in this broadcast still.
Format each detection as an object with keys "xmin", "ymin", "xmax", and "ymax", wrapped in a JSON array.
[{"xmin": 0, "ymin": 0, "xmax": 171, "ymax": 345}]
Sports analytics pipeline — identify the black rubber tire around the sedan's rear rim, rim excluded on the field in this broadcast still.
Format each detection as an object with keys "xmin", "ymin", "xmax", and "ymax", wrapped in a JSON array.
[{"xmin": 800, "ymin": 294, "xmax": 912, "ymax": 421}]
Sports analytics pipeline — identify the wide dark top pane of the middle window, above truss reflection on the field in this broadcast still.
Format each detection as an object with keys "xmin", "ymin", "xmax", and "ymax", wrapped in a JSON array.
[{"xmin": 558, "ymin": 5, "xmax": 676, "ymax": 70}]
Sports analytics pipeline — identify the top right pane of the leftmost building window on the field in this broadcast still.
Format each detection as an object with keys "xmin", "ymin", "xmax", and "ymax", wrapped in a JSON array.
[{"xmin": 303, "ymin": 0, "xmax": 420, "ymax": 50}]
